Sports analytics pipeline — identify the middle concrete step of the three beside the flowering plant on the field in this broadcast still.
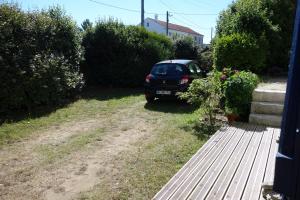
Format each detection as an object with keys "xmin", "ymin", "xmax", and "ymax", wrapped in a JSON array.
[{"xmin": 251, "ymin": 101, "xmax": 283, "ymax": 115}]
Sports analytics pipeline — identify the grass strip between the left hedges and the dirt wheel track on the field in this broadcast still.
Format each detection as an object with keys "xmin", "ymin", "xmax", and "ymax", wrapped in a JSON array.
[{"xmin": 0, "ymin": 89, "xmax": 142, "ymax": 147}]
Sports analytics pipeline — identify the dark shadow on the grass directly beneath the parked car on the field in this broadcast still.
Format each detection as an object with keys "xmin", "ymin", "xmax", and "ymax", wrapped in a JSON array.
[{"xmin": 144, "ymin": 99, "xmax": 197, "ymax": 114}]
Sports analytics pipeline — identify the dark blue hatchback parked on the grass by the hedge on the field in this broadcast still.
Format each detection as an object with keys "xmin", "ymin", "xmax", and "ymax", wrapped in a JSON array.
[{"xmin": 145, "ymin": 60, "xmax": 207, "ymax": 103}]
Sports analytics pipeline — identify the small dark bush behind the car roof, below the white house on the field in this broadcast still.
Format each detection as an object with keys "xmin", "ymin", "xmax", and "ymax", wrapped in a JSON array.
[{"xmin": 174, "ymin": 37, "xmax": 198, "ymax": 60}]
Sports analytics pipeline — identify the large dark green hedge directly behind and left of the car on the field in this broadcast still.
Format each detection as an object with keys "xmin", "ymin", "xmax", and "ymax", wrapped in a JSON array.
[{"xmin": 83, "ymin": 19, "xmax": 173, "ymax": 87}]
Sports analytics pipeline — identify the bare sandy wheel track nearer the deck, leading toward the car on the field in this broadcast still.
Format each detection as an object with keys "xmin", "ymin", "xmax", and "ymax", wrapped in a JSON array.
[{"xmin": 45, "ymin": 117, "xmax": 150, "ymax": 199}]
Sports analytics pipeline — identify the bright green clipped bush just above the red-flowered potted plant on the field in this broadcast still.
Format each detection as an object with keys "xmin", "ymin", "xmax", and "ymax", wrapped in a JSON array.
[{"xmin": 214, "ymin": 33, "xmax": 266, "ymax": 73}]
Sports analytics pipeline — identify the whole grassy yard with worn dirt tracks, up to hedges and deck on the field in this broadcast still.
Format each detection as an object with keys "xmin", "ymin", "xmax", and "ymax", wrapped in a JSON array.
[{"xmin": 0, "ymin": 89, "xmax": 216, "ymax": 199}]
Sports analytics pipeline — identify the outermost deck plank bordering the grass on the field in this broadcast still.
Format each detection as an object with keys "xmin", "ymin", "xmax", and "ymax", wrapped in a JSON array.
[{"xmin": 153, "ymin": 127, "xmax": 232, "ymax": 200}]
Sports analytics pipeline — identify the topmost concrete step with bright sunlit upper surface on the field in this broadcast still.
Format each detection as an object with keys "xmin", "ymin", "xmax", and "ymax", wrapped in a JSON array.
[{"xmin": 252, "ymin": 89, "xmax": 285, "ymax": 104}]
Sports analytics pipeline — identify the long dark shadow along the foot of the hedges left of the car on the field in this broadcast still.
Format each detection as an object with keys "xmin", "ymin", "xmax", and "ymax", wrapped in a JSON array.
[{"xmin": 0, "ymin": 87, "xmax": 143, "ymax": 125}]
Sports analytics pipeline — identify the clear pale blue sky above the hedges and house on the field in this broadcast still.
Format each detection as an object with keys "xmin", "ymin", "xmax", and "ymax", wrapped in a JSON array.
[{"xmin": 13, "ymin": 0, "xmax": 232, "ymax": 43}]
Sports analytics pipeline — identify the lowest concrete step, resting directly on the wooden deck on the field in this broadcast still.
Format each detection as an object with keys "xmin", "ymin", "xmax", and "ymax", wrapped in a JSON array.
[{"xmin": 249, "ymin": 113, "xmax": 282, "ymax": 127}]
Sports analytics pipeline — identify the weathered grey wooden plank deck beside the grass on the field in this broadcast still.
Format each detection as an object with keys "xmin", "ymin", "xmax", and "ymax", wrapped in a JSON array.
[{"xmin": 153, "ymin": 124, "xmax": 280, "ymax": 200}]
